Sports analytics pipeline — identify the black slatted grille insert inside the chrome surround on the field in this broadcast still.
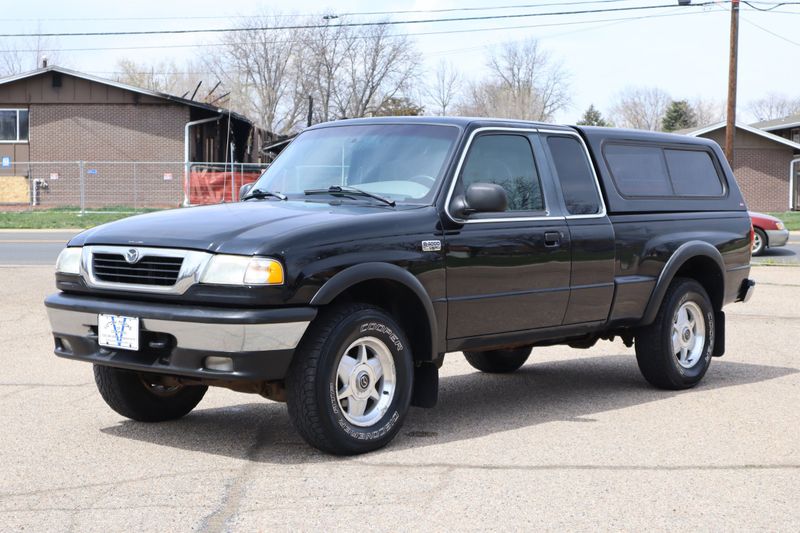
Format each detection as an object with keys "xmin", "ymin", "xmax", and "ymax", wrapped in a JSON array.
[{"xmin": 92, "ymin": 253, "xmax": 183, "ymax": 287}]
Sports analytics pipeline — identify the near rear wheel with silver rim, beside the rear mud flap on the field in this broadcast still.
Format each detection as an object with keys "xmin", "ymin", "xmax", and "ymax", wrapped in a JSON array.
[{"xmin": 636, "ymin": 278, "xmax": 715, "ymax": 390}]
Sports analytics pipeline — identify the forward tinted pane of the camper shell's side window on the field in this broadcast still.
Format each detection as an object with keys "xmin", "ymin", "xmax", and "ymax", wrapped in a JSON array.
[{"xmin": 603, "ymin": 144, "xmax": 673, "ymax": 196}]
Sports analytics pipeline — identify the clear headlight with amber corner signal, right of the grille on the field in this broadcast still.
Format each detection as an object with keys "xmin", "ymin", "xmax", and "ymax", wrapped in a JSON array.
[{"xmin": 200, "ymin": 255, "xmax": 283, "ymax": 285}]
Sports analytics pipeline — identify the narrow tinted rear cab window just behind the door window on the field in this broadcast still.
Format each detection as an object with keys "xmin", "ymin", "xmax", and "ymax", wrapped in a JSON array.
[{"xmin": 547, "ymin": 135, "xmax": 600, "ymax": 215}]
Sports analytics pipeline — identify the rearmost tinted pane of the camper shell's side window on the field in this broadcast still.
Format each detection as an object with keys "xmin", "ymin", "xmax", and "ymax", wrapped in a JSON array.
[{"xmin": 664, "ymin": 150, "xmax": 724, "ymax": 196}]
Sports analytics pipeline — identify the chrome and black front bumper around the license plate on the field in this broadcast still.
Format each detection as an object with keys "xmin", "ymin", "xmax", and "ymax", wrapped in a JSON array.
[{"xmin": 44, "ymin": 293, "xmax": 317, "ymax": 381}]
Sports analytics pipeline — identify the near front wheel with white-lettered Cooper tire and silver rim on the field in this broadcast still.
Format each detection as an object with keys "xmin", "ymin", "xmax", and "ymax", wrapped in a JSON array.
[{"xmin": 286, "ymin": 303, "xmax": 414, "ymax": 455}]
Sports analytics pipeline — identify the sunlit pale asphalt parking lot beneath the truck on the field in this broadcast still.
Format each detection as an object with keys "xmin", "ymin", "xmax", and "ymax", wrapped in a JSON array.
[{"xmin": 0, "ymin": 265, "xmax": 800, "ymax": 532}]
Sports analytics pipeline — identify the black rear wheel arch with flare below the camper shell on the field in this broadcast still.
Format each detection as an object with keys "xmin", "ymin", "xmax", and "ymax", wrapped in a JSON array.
[{"xmin": 640, "ymin": 241, "xmax": 725, "ymax": 326}]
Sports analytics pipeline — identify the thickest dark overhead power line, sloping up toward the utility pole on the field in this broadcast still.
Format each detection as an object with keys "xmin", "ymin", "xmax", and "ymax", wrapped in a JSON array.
[{"xmin": 0, "ymin": 0, "xmax": 730, "ymax": 37}]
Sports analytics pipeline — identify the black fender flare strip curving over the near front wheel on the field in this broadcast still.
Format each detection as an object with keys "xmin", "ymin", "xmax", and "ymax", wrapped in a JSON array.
[{"xmin": 310, "ymin": 262, "xmax": 439, "ymax": 360}]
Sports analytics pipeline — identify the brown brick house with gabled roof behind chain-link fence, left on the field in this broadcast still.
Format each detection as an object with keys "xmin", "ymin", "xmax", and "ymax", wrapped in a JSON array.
[{"xmin": 0, "ymin": 66, "xmax": 266, "ymax": 205}]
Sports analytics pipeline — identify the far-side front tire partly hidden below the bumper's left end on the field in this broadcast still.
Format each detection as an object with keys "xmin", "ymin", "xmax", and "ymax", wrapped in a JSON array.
[{"xmin": 94, "ymin": 365, "xmax": 208, "ymax": 422}]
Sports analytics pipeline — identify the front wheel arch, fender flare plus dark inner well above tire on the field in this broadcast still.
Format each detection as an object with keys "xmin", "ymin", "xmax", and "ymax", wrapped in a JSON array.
[{"xmin": 311, "ymin": 263, "xmax": 438, "ymax": 361}]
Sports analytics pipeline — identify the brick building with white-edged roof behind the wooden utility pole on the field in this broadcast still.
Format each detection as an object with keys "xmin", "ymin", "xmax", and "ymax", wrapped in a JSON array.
[{"xmin": 680, "ymin": 122, "xmax": 800, "ymax": 212}]
